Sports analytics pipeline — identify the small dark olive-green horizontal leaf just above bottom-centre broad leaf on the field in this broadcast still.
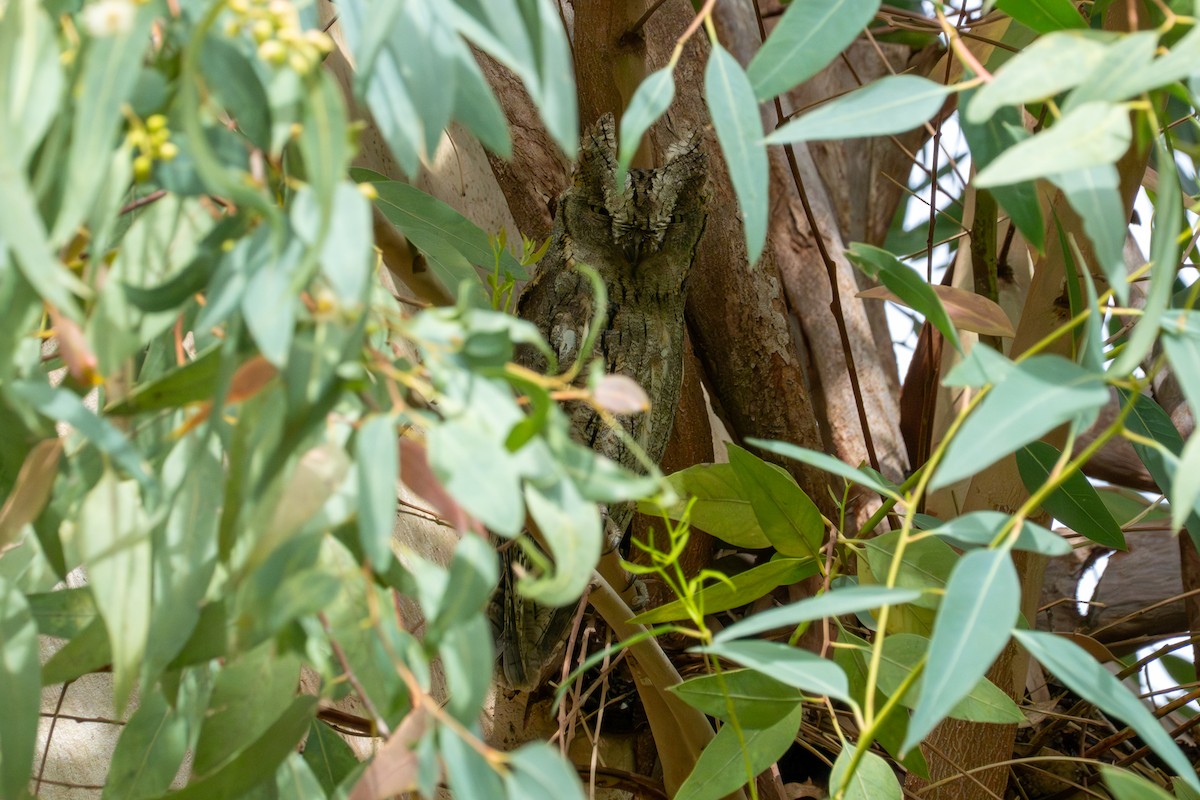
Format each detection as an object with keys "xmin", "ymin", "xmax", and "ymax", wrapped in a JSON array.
[{"xmin": 668, "ymin": 669, "xmax": 804, "ymax": 728}]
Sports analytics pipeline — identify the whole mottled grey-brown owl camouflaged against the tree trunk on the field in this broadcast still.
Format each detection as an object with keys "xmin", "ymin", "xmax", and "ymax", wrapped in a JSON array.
[{"xmin": 500, "ymin": 115, "xmax": 708, "ymax": 688}]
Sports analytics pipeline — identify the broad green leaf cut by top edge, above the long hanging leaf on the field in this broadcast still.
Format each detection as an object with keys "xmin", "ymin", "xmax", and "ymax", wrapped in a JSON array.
[{"xmin": 746, "ymin": 0, "xmax": 880, "ymax": 100}]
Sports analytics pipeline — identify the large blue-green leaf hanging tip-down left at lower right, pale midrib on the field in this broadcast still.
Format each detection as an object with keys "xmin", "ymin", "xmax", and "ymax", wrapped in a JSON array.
[{"xmin": 901, "ymin": 549, "xmax": 1021, "ymax": 751}]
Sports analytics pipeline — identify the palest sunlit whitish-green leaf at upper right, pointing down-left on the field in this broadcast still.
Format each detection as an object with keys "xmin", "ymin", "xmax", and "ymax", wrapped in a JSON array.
[{"xmin": 976, "ymin": 102, "xmax": 1133, "ymax": 188}]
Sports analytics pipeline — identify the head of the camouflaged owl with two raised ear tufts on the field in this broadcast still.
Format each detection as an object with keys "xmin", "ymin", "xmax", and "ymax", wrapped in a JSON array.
[{"xmin": 558, "ymin": 115, "xmax": 708, "ymax": 294}]
